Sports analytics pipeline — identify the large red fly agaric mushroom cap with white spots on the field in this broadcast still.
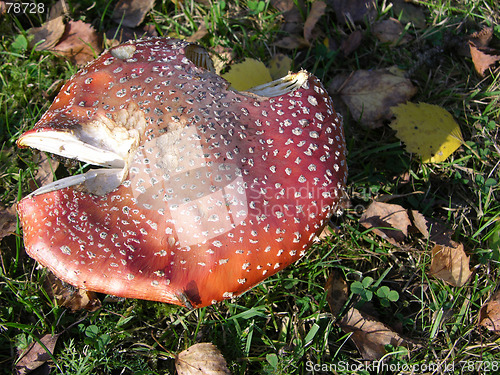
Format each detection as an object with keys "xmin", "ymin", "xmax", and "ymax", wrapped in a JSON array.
[{"xmin": 14, "ymin": 38, "xmax": 347, "ymax": 307}]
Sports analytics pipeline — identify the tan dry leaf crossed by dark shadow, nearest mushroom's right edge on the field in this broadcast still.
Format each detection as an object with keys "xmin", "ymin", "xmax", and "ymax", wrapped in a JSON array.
[{"xmin": 359, "ymin": 202, "xmax": 411, "ymax": 245}]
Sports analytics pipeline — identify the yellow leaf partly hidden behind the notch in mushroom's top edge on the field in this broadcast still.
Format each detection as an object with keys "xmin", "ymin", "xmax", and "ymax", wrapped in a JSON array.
[{"xmin": 222, "ymin": 59, "xmax": 272, "ymax": 91}]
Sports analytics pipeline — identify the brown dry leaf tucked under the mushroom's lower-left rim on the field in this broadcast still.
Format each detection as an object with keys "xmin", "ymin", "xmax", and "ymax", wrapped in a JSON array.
[{"xmin": 43, "ymin": 272, "xmax": 101, "ymax": 311}]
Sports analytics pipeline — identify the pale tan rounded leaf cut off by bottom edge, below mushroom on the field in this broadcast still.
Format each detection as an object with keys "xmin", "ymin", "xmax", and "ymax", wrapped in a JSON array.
[{"xmin": 175, "ymin": 342, "xmax": 231, "ymax": 375}]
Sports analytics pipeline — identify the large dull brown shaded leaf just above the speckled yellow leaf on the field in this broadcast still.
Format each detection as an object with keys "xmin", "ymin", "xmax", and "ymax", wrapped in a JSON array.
[{"xmin": 328, "ymin": 69, "xmax": 417, "ymax": 128}]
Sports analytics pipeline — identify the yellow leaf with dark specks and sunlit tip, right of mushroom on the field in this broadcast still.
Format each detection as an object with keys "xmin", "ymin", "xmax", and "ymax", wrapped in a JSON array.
[{"xmin": 391, "ymin": 103, "xmax": 463, "ymax": 163}]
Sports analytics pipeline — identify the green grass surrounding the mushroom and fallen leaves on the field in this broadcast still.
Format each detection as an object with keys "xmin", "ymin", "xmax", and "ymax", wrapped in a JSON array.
[{"xmin": 0, "ymin": 0, "xmax": 500, "ymax": 374}]
